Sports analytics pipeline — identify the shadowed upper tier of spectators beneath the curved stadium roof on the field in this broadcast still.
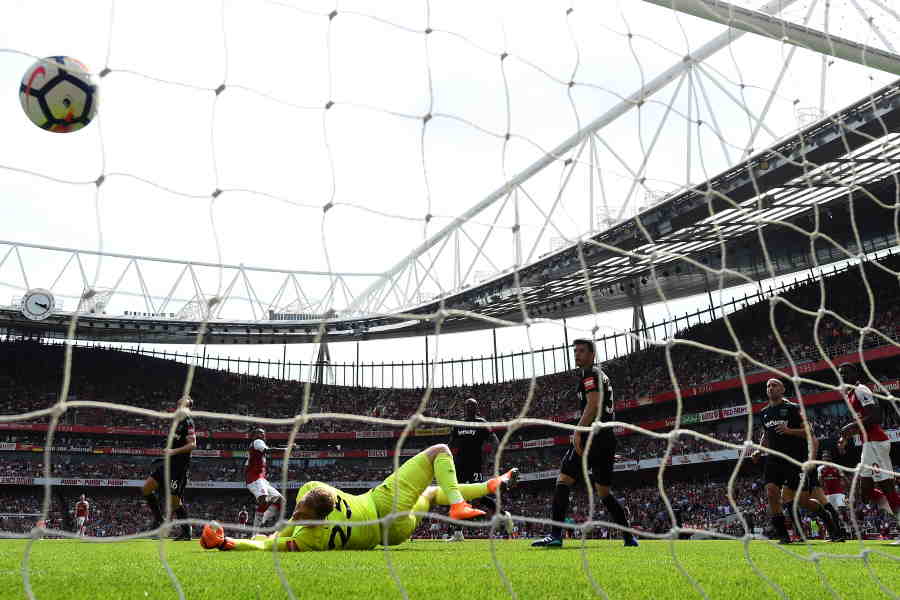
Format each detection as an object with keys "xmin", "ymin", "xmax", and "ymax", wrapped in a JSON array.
[{"xmin": 0, "ymin": 257, "xmax": 900, "ymax": 440}]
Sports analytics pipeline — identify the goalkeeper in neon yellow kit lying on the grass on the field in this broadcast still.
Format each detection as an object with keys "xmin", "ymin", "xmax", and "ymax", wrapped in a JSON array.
[{"xmin": 200, "ymin": 444, "xmax": 519, "ymax": 552}]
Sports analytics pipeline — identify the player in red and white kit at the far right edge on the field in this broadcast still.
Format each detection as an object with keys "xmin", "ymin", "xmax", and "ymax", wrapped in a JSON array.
[{"xmin": 838, "ymin": 363, "xmax": 900, "ymax": 521}]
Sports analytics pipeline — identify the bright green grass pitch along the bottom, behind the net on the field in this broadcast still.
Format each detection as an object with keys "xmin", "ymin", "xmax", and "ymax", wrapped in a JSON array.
[{"xmin": 0, "ymin": 540, "xmax": 900, "ymax": 600}]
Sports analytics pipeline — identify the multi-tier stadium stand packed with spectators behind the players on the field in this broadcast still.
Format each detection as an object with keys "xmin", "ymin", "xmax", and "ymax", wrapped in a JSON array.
[{"xmin": 0, "ymin": 257, "xmax": 900, "ymax": 537}]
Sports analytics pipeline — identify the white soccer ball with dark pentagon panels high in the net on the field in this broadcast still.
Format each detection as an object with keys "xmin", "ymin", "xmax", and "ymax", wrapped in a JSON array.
[{"xmin": 19, "ymin": 56, "xmax": 100, "ymax": 133}]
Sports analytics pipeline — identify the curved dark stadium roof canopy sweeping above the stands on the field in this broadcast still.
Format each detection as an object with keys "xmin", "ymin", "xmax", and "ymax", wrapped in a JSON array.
[{"xmin": 0, "ymin": 82, "xmax": 900, "ymax": 344}]
